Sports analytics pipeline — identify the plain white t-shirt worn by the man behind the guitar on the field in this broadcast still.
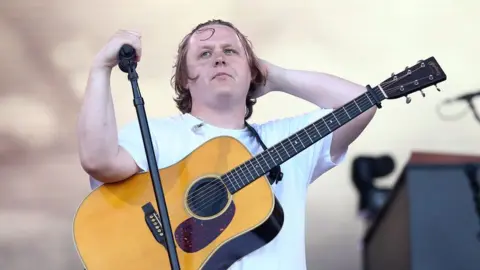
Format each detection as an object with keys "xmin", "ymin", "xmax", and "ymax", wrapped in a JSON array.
[{"xmin": 90, "ymin": 109, "xmax": 346, "ymax": 270}]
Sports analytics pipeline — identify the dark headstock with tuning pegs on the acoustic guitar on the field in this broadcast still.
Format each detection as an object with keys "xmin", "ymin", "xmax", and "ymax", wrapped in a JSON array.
[{"xmin": 379, "ymin": 56, "xmax": 447, "ymax": 103}]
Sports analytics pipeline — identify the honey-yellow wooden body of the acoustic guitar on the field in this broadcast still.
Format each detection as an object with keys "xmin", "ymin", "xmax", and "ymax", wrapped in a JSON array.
[{"xmin": 73, "ymin": 137, "xmax": 283, "ymax": 270}]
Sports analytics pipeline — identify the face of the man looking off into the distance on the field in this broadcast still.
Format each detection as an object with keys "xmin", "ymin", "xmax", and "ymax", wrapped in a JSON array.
[{"xmin": 187, "ymin": 25, "xmax": 251, "ymax": 105}]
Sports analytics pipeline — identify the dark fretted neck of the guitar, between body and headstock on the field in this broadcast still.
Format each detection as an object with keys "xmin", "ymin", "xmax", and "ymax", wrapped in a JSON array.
[{"xmin": 222, "ymin": 86, "xmax": 385, "ymax": 194}]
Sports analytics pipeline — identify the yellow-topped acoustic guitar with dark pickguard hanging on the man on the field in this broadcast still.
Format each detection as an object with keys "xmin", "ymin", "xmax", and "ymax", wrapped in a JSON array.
[{"xmin": 73, "ymin": 57, "xmax": 447, "ymax": 270}]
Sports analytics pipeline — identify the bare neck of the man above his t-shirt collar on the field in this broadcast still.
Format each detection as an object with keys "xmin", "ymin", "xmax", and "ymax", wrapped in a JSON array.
[{"xmin": 190, "ymin": 104, "xmax": 245, "ymax": 129}]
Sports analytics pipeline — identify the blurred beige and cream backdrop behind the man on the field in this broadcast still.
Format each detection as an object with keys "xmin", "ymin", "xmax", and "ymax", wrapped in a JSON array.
[{"xmin": 0, "ymin": 0, "xmax": 480, "ymax": 270}]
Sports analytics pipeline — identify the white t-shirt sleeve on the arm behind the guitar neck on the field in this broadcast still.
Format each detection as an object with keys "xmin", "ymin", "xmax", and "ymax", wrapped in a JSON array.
[{"xmin": 258, "ymin": 108, "xmax": 347, "ymax": 185}]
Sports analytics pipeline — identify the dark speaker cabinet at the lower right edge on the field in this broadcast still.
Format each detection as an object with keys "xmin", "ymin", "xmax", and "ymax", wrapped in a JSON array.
[{"xmin": 363, "ymin": 153, "xmax": 480, "ymax": 270}]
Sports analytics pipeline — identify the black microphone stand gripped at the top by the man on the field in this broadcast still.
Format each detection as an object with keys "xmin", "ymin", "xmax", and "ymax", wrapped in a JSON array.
[{"xmin": 118, "ymin": 44, "xmax": 180, "ymax": 270}]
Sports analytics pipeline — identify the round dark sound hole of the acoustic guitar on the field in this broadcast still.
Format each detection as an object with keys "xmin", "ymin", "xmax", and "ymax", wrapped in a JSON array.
[{"xmin": 187, "ymin": 177, "xmax": 228, "ymax": 218}]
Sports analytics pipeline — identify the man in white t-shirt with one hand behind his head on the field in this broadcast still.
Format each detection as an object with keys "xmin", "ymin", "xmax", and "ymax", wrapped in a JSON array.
[{"xmin": 78, "ymin": 20, "xmax": 375, "ymax": 270}]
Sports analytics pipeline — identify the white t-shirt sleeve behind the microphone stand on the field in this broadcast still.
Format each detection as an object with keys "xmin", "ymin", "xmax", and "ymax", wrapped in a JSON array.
[{"xmin": 118, "ymin": 121, "xmax": 158, "ymax": 172}]
